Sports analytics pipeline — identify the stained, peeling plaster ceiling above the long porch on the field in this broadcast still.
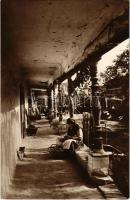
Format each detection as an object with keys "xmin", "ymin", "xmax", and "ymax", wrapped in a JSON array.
[{"xmin": 2, "ymin": 0, "xmax": 128, "ymax": 83}]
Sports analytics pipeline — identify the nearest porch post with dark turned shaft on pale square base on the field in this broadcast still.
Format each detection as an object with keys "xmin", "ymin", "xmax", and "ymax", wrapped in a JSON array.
[{"xmin": 88, "ymin": 61, "xmax": 112, "ymax": 180}]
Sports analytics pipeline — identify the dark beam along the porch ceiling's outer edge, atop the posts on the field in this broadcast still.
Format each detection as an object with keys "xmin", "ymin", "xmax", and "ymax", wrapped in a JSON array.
[{"xmin": 53, "ymin": 10, "xmax": 129, "ymax": 84}]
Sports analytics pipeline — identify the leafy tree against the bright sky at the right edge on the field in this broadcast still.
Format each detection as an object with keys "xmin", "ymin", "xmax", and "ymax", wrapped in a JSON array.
[{"xmin": 101, "ymin": 47, "xmax": 129, "ymax": 124}]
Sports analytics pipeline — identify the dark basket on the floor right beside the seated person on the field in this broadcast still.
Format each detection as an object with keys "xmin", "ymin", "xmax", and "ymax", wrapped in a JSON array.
[{"xmin": 48, "ymin": 144, "xmax": 67, "ymax": 159}]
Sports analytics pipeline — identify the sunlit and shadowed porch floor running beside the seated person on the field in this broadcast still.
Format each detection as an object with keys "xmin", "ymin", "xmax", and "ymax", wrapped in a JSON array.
[{"xmin": 7, "ymin": 121, "xmax": 104, "ymax": 199}]
